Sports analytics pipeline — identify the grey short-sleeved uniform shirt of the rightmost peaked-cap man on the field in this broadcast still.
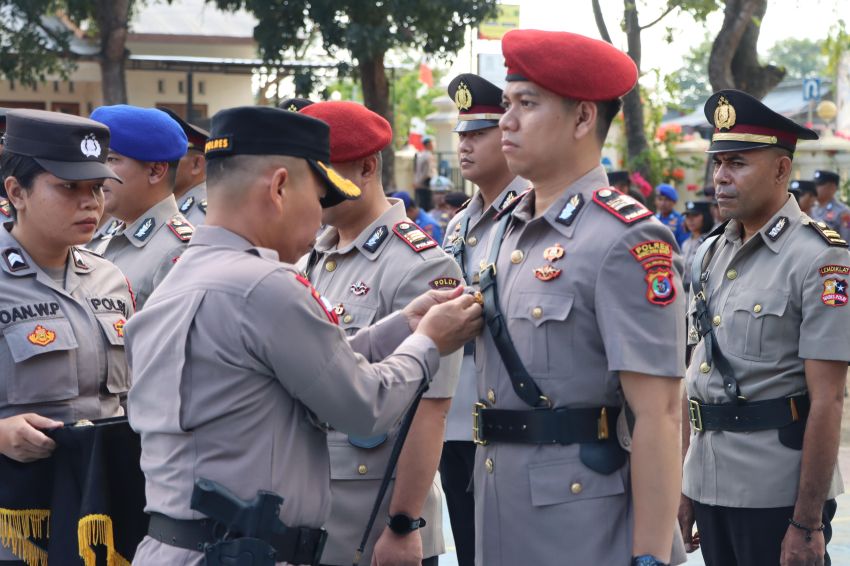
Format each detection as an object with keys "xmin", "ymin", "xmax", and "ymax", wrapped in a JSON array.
[{"xmin": 683, "ymin": 197, "xmax": 850, "ymax": 507}]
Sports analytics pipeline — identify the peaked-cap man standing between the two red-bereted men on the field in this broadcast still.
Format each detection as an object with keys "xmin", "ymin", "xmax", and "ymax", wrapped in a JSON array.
[{"xmin": 440, "ymin": 73, "xmax": 529, "ymax": 566}]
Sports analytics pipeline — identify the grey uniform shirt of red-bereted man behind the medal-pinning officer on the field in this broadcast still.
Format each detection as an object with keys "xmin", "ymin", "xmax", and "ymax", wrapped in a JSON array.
[{"xmin": 298, "ymin": 199, "xmax": 463, "ymax": 566}]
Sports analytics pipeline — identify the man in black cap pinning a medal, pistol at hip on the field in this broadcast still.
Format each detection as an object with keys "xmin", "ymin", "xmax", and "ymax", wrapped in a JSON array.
[{"xmin": 127, "ymin": 107, "xmax": 481, "ymax": 566}]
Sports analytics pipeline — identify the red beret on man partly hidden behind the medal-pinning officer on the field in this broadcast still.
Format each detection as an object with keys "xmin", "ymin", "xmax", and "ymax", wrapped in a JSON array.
[{"xmin": 299, "ymin": 102, "xmax": 393, "ymax": 163}]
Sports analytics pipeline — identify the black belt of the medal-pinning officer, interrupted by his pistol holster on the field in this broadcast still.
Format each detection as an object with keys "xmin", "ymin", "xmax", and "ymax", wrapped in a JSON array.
[{"xmin": 148, "ymin": 513, "xmax": 327, "ymax": 565}]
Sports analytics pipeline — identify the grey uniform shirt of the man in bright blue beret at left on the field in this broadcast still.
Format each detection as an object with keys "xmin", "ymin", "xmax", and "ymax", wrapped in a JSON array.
[{"xmin": 90, "ymin": 196, "xmax": 194, "ymax": 310}]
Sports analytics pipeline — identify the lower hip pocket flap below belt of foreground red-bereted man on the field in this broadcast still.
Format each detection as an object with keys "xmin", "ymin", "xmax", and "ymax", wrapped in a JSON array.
[{"xmin": 528, "ymin": 456, "xmax": 625, "ymax": 507}]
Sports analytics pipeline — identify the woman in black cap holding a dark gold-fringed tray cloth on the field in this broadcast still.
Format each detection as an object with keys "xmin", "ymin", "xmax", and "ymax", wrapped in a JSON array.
[{"xmin": 0, "ymin": 110, "xmax": 133, "ymax": 564}]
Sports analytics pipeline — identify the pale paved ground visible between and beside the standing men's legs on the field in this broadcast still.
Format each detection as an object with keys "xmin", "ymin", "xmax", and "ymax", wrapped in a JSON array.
[{"xmin": 440, "ymin": 399, "xmax": 850, "ymax": 566}]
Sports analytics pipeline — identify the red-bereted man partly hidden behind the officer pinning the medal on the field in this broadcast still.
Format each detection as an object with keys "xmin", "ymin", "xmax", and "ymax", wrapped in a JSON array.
[{"xmin": 298, "ymin": 102, "xmax": 462, "ymax": 566}]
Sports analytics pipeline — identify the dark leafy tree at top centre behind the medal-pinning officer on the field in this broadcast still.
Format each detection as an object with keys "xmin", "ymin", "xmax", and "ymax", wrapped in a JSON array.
[{"xmin": 208, "ymin": 0, "xmax": 497, "ymax": 188}]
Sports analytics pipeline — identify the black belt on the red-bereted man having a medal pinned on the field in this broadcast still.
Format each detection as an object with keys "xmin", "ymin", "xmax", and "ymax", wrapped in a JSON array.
[{"xmin": 472, "ymin": 403, "xmax": 620, "ymax": 445}]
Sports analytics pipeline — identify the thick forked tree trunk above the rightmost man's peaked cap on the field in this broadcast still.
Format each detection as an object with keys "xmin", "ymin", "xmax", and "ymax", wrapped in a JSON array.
[{"xmin": 708, "ymin": 0, "xmax": 785, "ymax": 98}]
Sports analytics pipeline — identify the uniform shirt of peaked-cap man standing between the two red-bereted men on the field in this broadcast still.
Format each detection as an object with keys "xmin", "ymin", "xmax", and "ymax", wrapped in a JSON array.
[{"xmin": 443, "ymin": 177, "xmax": 529, "ymax": 442}]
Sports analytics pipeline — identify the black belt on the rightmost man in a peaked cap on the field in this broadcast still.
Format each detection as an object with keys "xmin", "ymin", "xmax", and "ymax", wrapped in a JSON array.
[{"xmin": 688, "ymin": 395, "xmax": 809, "ymax": 432}]
